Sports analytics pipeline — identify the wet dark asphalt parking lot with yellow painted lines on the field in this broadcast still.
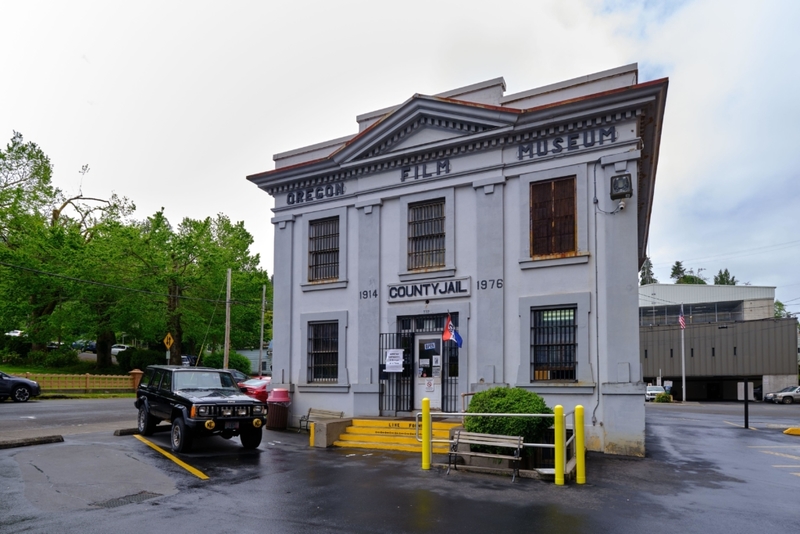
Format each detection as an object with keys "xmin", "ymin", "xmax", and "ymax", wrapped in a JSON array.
[{"xmin": 0, "ymin": 399, "xmax": 800, "ymax": 533}]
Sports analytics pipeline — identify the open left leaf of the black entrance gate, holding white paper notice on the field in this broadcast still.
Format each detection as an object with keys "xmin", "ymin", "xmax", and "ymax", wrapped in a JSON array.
[{"xmin": 378, "ymin": 332, "xmax": 414, "ymax": 415}]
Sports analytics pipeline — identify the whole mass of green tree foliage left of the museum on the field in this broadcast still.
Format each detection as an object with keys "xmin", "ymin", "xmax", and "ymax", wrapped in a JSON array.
[{"xmin": 0, "ymin": 132, "xmax": 272, "ymax": 366}]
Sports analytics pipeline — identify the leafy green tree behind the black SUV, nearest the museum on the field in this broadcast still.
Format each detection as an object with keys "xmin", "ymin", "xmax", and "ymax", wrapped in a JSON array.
[{"xmin": 128, "ymin": 210, "xmax": 271, "ymax": 365}]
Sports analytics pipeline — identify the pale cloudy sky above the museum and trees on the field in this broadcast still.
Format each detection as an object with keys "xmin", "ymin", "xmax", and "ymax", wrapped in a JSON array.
[{"xmin": 0, "ymin": 0, "xmax": 800, "ymax": 312}]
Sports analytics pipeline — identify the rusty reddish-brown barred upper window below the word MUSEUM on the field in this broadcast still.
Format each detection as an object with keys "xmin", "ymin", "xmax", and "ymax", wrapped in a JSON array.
[{"xmin": 530, "ymin": 176, "xmax": 577, "ymax": 257}]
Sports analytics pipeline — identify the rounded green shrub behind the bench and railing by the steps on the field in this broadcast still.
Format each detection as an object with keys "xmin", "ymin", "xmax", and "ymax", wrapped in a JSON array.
[{"xmin": 464, "ymin": 387, "xmax": 553, "ymax": 450}]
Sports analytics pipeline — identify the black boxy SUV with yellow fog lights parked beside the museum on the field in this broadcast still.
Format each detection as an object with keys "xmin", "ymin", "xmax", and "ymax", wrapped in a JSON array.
[{"xmin": 134, "ymin": 365, "xmax": 267, "ymax": 452}]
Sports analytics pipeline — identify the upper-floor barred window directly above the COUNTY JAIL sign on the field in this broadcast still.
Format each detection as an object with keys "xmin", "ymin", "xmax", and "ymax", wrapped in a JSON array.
[{"xmin": 408, "ymin": 198, "xmax": 446, "ymax": 271}]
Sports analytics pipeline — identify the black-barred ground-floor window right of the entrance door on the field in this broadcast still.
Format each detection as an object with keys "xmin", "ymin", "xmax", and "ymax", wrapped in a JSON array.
[{"xmin": 531, "ymin": 308, "xmax": 578, "ymax": 382}]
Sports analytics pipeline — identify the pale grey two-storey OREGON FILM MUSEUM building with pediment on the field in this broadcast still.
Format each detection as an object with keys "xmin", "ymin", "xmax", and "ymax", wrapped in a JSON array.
[{"xmin": 248, "ymin": 65, "xmax": 668, "ymax": 455}]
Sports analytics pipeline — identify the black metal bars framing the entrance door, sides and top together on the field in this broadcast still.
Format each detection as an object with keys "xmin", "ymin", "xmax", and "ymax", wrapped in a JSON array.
[{"xmin": 378, "ymin": 313, "xmax": 461, "ymax": 415}]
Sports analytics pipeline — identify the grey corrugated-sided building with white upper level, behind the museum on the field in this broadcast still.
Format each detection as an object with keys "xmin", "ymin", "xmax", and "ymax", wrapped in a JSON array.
[{"xmin": 639, "ymin": 284, "xmax": 797, "ymax": 400}]
